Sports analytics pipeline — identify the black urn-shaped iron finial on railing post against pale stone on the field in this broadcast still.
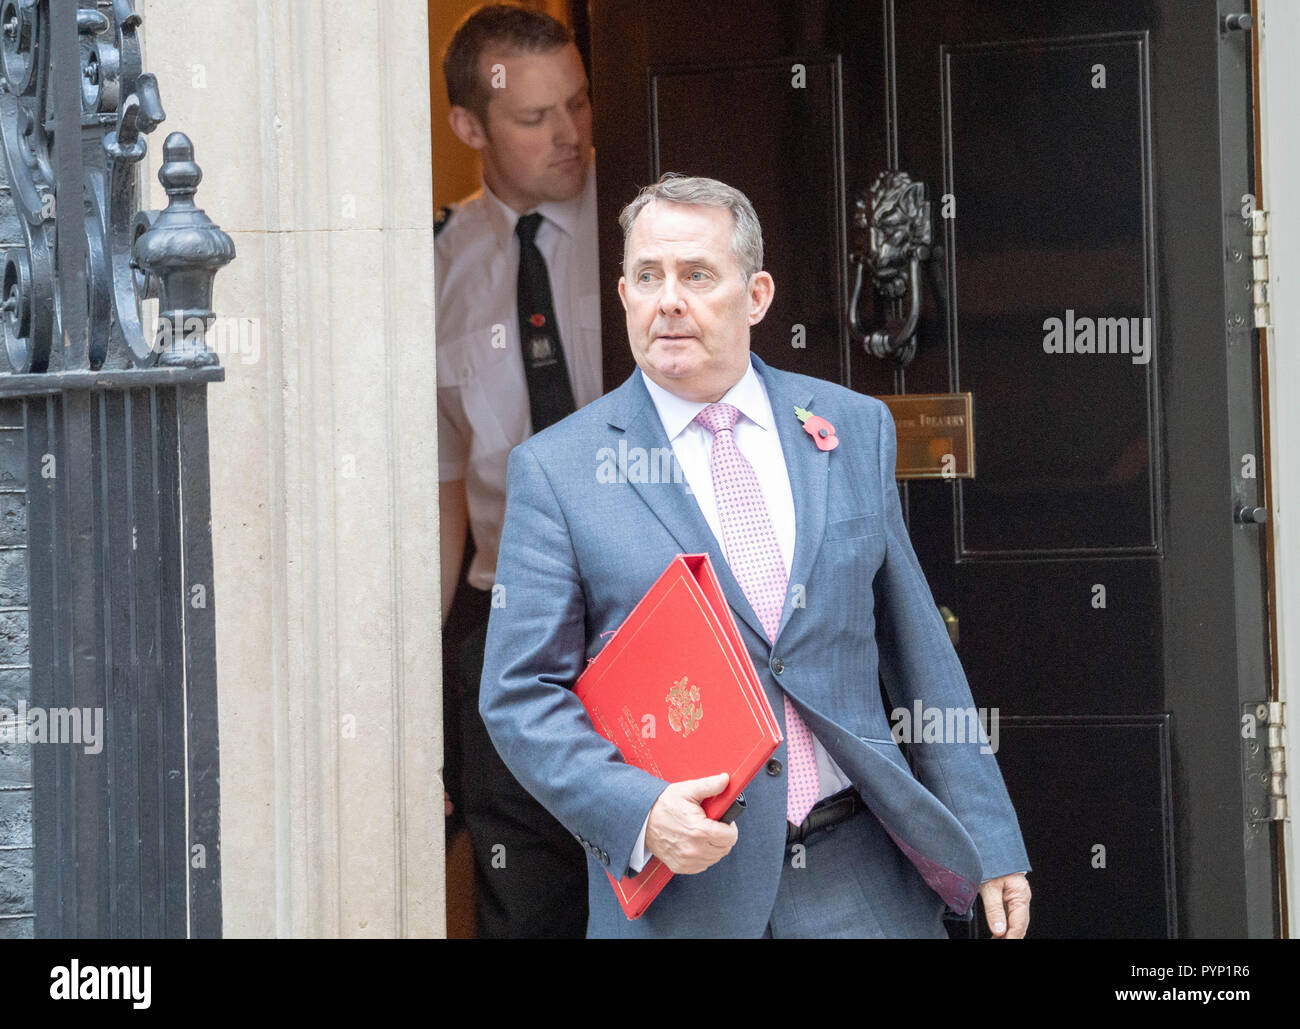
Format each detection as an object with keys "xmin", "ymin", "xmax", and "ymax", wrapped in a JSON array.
[{"xmin": 134, "ymin": 133, "xmax": 235, "ymax": 368}]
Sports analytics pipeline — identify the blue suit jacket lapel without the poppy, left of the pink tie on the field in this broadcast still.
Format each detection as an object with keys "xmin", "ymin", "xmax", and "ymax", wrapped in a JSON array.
[{"xmin": 608, "ymin": 370, "xmax": 769, "ymax": 642}]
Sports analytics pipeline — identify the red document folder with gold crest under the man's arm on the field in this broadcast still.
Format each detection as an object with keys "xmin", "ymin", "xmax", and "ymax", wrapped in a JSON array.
[{"xmin": 573, "ymin": 553, "xmax": 781, "ymax": 919}]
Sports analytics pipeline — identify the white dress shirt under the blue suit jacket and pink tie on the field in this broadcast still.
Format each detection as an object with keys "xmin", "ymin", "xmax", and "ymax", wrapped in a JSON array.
[{"xmin": 632, "ymin": 365, "xmax": 853, "ymax": 872}]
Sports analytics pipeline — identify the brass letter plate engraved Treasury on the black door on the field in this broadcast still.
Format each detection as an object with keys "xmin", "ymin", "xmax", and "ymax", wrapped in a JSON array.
[{"xmin": 876, "ymin": 392, "xmax": 975, "ymax": 479}]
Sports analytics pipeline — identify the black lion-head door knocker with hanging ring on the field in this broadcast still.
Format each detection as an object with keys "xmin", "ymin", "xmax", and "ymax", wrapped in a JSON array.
[{"xmin": 849, "ymin": 172, "xmax": 931, "ymax": 365}]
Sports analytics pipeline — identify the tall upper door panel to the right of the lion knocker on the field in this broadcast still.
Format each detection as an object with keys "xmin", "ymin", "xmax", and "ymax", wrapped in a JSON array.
[{"xmin": 946, "ymin": 34, "xmax": 1160, "ymax": 559}]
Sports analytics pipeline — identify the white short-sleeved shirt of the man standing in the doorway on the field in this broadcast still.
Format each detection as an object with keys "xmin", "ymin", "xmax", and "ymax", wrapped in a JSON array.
[{"xmin": 434, "ymin": 152, "xmax": 602, "ymax": 590}]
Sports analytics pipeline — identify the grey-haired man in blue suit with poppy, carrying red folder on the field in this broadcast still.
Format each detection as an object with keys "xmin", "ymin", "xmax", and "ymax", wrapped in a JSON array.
[{"xmin": 481, "ymin": 175, "xmax": 1030, "ymax": 938}]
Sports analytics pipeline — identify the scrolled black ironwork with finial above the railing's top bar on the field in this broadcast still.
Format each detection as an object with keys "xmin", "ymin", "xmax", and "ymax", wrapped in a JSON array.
[{"xmin": 0, "ymin": 0, "xmax": 234, "ymax": 374}]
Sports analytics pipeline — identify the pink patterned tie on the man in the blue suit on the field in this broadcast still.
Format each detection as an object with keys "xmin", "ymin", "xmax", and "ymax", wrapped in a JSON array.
[{"xmin": 696, "ymin": 404, "xmax": 820, "ymax": 825}]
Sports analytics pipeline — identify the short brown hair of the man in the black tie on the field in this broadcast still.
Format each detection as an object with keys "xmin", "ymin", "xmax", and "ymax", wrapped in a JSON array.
[{"xmin": 442, "ymin": 4, "xmax": 573, "ymax": 127}]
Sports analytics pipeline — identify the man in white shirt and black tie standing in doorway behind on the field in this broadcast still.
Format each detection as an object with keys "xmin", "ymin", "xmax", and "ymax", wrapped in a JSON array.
[{"xmin": 436, "ymin": 4, "xmax": 601, "ymax": 937}]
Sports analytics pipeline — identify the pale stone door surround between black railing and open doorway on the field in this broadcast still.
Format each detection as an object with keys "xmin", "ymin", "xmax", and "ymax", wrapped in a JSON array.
[{"xmin": 138, "ymin": 0, "xmax": 445, "ymax": 937}]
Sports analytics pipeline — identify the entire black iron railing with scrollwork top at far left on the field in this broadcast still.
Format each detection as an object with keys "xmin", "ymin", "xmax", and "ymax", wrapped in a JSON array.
[{"xmin": 0, "ymin": 0, "xmax": 234, "ymax": 937}]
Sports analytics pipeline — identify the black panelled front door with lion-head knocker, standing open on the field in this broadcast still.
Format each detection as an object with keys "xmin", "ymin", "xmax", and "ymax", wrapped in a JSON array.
[{"xmin": 592, "ymin": 0, "xmax": 1277, "ymax": 937}]
